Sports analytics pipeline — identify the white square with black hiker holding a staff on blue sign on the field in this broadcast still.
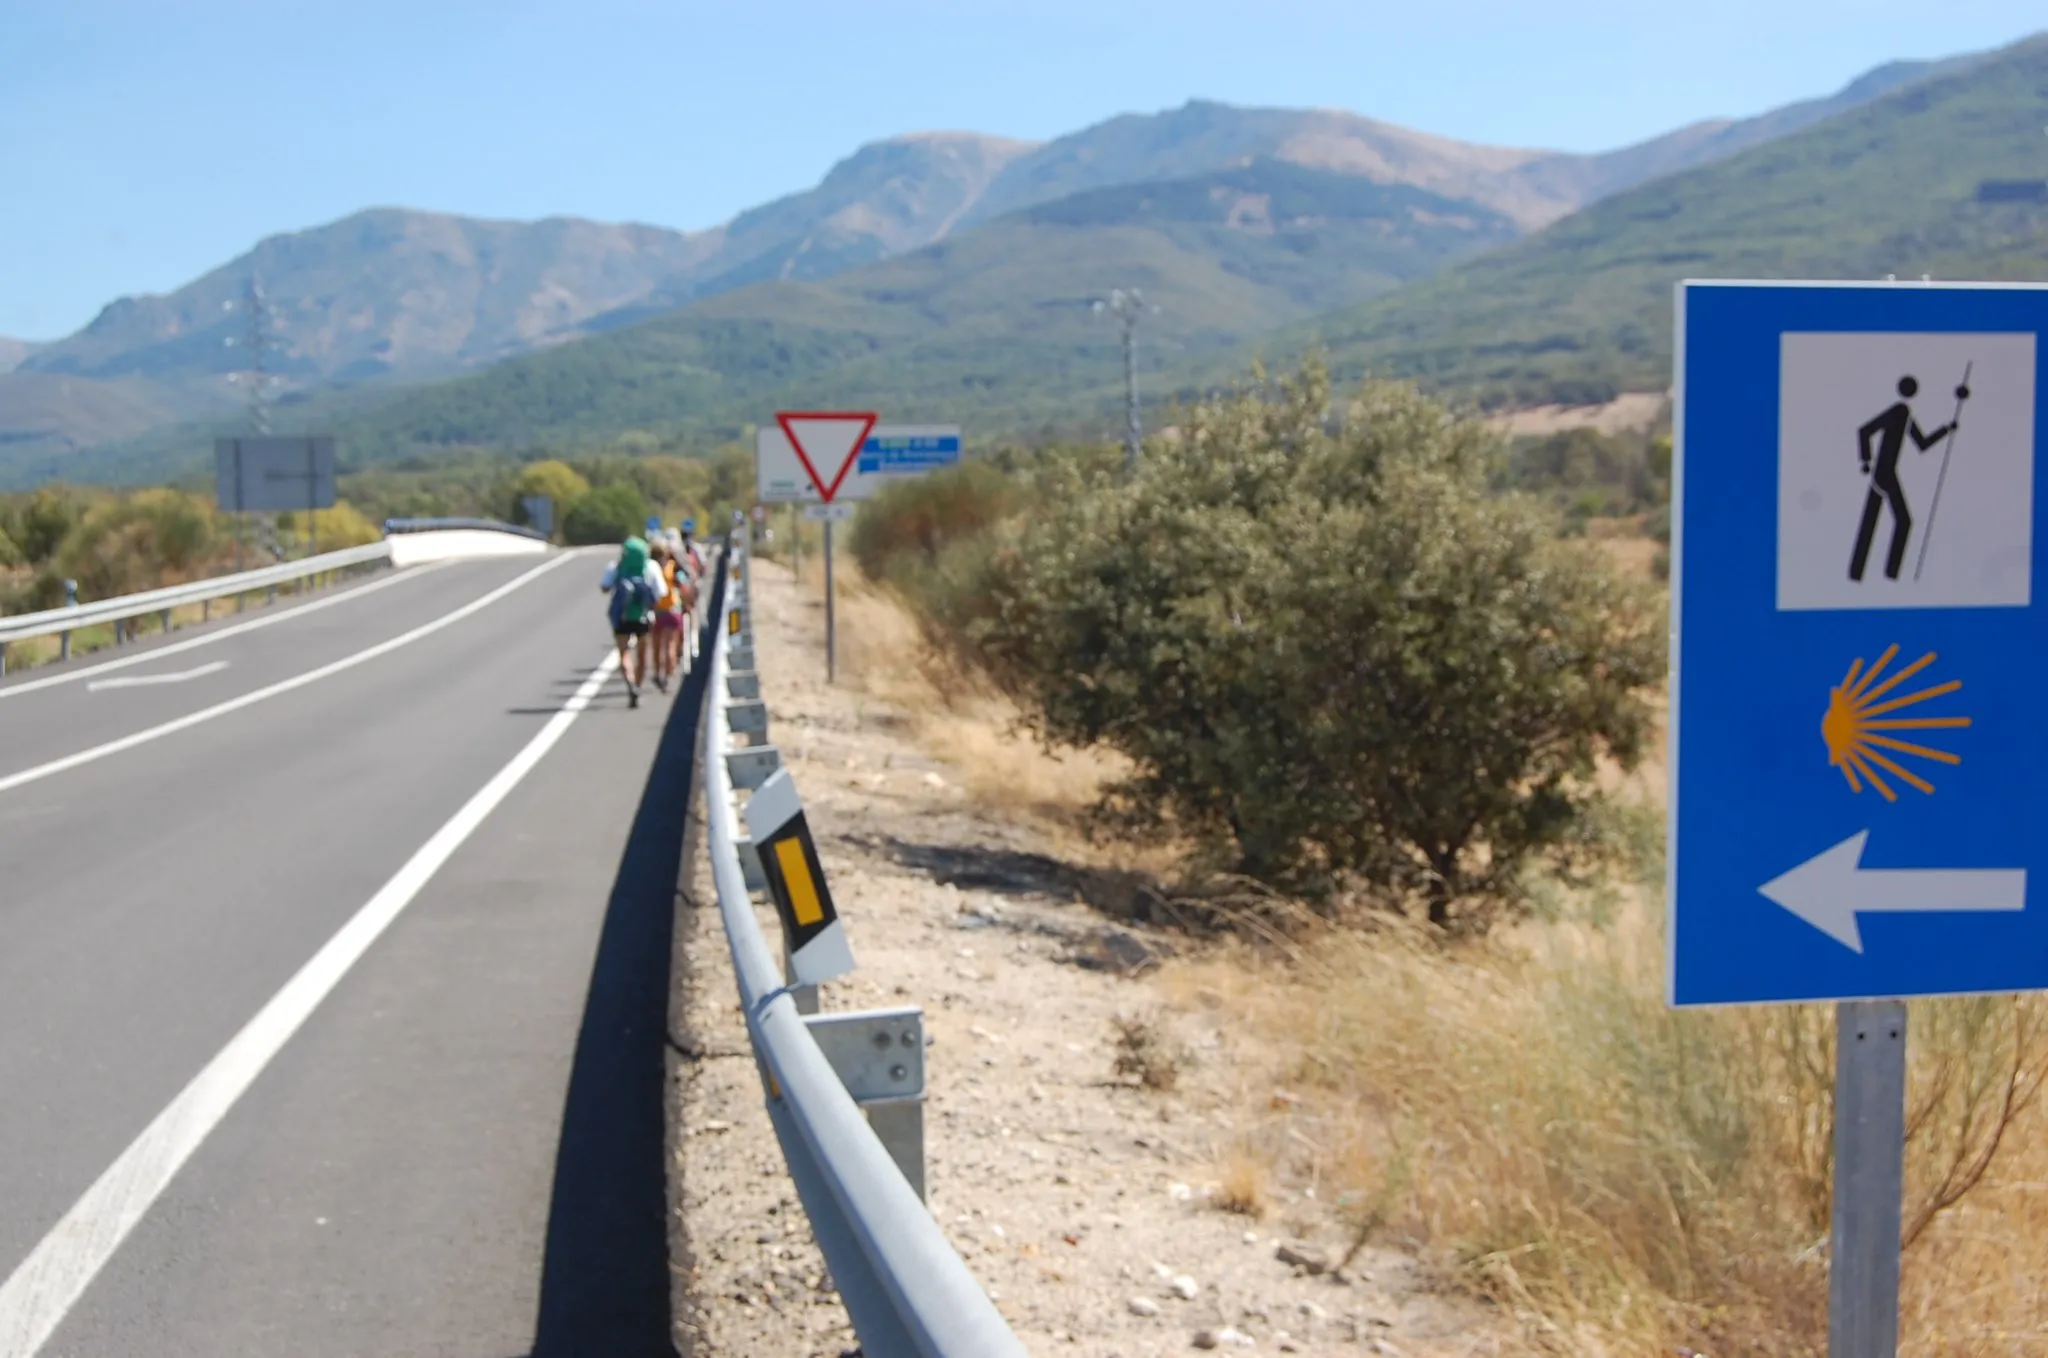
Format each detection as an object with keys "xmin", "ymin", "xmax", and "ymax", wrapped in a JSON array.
[{"xmin": 1778, "ymin": 332, "xmax": 2036, "ymax": 610}]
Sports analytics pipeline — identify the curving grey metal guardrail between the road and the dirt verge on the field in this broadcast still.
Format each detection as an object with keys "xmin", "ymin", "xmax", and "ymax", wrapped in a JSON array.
[{"xmin": 700, "ymin": 535, "xmax": 1024, "ymax": 1358}]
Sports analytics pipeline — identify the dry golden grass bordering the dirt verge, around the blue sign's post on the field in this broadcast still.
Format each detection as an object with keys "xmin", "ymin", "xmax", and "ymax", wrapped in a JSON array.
[{"xmin": 823, "ymin": 548, "xmax": 2048, "ymax": 1358}]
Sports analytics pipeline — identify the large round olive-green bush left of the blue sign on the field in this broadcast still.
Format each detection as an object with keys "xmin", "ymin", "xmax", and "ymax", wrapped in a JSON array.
[{"xmin": 934, "ymin": 365, "xmax": 1665, "ymax": 924}]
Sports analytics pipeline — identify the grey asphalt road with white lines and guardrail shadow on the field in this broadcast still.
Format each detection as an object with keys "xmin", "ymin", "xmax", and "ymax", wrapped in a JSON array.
[{"xmin": 0, "ymin": 557, "xmax": 698, "ymax": 1358}]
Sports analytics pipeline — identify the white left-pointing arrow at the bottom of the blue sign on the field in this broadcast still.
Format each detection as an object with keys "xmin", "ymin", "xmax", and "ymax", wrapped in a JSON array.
[{"xmin": 1757, "ymin": 830, "xmax": 2028, "ymax": 952}]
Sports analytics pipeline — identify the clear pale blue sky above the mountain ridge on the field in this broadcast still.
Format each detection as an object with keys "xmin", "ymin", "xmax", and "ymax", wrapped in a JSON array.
[{"xmin": 0, "ymin": 0, "xmax": 2048, "ymax": 338}]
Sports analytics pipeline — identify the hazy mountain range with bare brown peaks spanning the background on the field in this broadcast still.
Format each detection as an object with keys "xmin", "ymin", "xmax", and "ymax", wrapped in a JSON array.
[{"xmin": 0, "ymin": 45, "xmax": 2015, "ymax": 483}]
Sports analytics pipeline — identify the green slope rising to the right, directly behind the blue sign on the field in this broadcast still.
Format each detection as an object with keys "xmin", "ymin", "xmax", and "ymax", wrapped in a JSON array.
[{"xmin": 1245, "ymin": 37, "xmax": 2048, "ymax": 406}]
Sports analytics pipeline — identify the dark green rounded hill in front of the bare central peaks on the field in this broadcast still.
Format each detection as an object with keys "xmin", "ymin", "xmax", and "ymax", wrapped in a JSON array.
[{"xmin": 303, "ymin": 162, "xmax": 1513, "ymax": 461}]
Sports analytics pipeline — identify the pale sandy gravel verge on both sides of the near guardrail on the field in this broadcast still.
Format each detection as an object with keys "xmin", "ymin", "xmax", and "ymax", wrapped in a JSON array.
[{"xmin": 674, "ymin": 563, "xmax": 1518, "ymax": 1358}]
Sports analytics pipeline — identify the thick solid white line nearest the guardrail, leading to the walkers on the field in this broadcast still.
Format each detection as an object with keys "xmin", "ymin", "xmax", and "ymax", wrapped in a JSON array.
[{"xmin": 0, "ymin": 651, "xmax": 618, "ymax": 1358}]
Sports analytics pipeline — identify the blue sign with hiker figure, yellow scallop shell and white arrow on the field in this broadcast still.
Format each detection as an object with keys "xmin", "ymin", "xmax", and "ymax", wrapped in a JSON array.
[{"xmin": 1669, "ymin": 283, "xmax": 2048, "ymax": 1006}]
